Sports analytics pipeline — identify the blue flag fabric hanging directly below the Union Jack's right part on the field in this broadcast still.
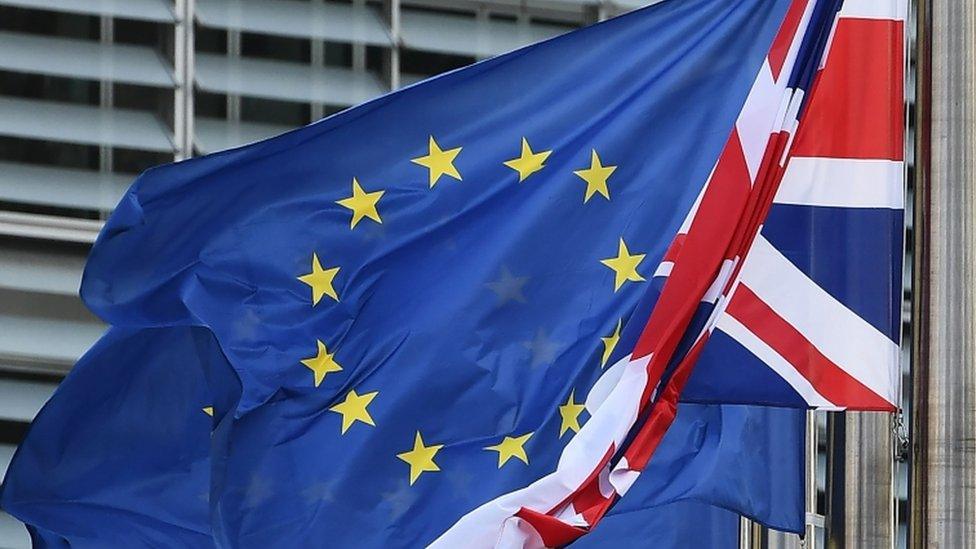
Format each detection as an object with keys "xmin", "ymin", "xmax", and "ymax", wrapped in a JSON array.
[{"xmin": 632, "ymin": 404, "xmax": 806, "ymax": 534}]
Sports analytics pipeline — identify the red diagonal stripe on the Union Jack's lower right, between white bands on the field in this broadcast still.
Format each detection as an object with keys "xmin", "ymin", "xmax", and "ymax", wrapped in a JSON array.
[{"xmin": 726, "ymin": 284, "xmax": 895, "ymax": 411}]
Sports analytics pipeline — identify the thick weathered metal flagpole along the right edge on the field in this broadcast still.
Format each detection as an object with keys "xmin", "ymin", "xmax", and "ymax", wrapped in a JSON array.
[{"xmin": 910, "ymin": 0, "xmax": 976, "ymax": 547}]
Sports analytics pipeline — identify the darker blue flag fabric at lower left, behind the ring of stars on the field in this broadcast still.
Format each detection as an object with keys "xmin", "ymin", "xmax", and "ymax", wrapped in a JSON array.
[{"xmin": 2, "ymin": 327, "xmax": 217, "ymax": 547}]
